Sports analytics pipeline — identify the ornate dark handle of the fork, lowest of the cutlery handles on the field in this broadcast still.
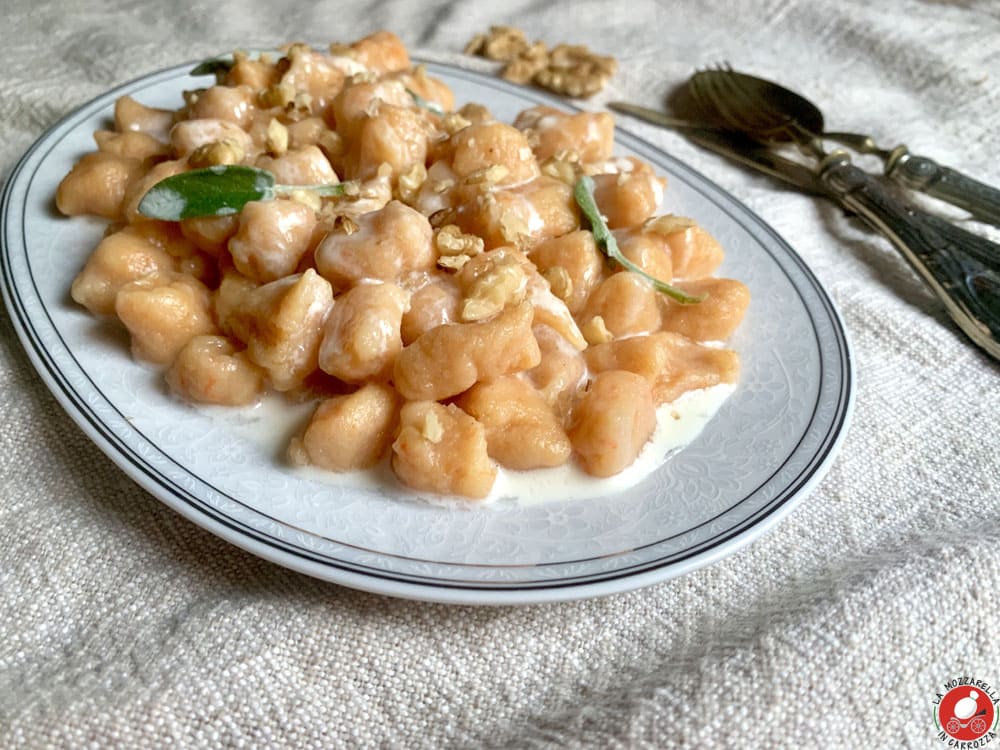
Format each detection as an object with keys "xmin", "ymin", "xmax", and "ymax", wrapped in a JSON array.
[{"xmin": 820, "ymin": 152, "xmax": 1000, "ymax": 359}]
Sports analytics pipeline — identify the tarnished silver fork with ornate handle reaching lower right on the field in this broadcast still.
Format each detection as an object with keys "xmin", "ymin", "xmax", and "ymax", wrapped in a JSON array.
[{"xmin": 688, "ymin": 65, "xmax": 1000, "ymax": 359}]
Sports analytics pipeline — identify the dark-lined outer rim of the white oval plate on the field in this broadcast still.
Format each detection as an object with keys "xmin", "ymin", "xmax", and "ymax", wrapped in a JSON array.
[{"xmin": 0, "ymin": 57, "xmax": 856, "ymax": 604}]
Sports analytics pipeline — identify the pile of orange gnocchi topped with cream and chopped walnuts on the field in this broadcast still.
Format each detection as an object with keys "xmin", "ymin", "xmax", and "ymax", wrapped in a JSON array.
[{"xmin": 56, "ymin": 32, "xmax": 749, "ymax": 498}]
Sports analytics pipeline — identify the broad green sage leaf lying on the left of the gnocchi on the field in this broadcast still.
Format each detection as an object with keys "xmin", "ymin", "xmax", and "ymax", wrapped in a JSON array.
[{"xmin": 139, "ymin": 165, "xmax": 276, "ymax": 221}]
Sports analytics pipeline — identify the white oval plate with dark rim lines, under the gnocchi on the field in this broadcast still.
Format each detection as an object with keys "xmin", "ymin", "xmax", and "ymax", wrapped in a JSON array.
[{"xmin": 2, "ymin": 64, "xmax": 853, "ymax": 604}]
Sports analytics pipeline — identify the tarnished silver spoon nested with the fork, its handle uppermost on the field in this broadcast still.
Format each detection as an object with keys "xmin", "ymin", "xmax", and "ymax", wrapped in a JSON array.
[{"xmin": 688, "ymin": 67, "xmax": 1000, "ymax": 226}]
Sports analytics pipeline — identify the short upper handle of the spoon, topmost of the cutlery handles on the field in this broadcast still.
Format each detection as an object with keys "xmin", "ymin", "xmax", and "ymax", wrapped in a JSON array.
[{"xmin": 885, "ymin": 146, "xmax": 1000, "ymax": 226}]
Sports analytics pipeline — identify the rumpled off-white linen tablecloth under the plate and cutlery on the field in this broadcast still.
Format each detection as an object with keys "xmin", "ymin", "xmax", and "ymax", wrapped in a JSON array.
[{"xmin": 0, "ymin": 0, "xmax": 1000, "ymax": 748}]
